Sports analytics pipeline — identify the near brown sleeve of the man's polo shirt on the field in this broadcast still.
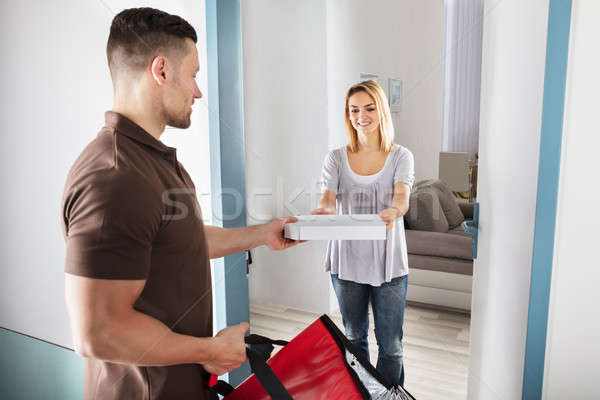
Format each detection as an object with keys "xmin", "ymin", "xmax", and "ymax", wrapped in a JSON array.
[{"xmin": 63, "ymin": 171, "xmax": 162, "ymax": 279}]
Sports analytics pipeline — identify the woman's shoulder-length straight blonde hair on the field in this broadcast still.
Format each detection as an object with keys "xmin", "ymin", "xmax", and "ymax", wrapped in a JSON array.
[{"xmin": 346, "ymin": 79, "xmax": 394, "ymax": 153}]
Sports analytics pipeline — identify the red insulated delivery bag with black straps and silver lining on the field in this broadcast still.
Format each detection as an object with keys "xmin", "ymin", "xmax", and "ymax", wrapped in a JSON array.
[{"xmin": 209, "ymin": 315, "xmax": 415, "ymax": 400}]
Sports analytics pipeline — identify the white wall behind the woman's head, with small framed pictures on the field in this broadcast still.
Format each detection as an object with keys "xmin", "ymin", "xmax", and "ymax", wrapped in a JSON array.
[{"xmin": 326, "ymin": 0, "xmax": 444, "ymax": 180}]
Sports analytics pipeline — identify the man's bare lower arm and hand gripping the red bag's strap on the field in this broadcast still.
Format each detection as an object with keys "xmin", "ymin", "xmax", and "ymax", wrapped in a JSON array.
[{"xmin": 65, "ymin": 274, "xmax": 249, "ymax": 375}]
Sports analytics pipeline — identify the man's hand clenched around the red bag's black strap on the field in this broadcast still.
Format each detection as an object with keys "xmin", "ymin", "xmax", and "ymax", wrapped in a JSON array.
[{"xmin": 203, "ymin": 322, "xmax": 250, "ymax": 376}]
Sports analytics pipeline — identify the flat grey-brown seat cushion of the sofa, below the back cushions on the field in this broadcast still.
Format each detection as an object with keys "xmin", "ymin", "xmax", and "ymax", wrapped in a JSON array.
[{"xmin": 405, "ymin": 229, "xmax": 473, "ymax": 260}]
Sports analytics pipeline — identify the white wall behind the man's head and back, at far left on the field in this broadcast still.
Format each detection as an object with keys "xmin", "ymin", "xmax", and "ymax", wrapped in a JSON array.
[{"xmin": 0, "ymin": 0, "xmax": 210, "ymax": 346}]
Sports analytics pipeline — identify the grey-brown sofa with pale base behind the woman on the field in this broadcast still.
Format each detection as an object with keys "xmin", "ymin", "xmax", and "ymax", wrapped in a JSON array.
[{"xmin": 405, "ymin": 180, "xmax": 473, "ymax": 311}]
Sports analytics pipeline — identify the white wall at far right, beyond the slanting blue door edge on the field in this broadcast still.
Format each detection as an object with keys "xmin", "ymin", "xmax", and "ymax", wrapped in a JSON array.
[{"xmin": 543, "ymin": 0, "xmax": 600, "ymax": 400}]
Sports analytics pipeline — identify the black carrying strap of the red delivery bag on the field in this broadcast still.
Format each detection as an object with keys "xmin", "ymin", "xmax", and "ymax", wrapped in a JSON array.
[{"xmin": 210, "ymin": 334, "xmax": 293, "ymax": 400}]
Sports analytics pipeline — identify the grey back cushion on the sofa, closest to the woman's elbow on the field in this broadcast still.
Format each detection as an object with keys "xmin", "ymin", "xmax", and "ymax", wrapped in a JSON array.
[{"xmin": 404, "ymin": 186, "xmax": 450, "ymax": 232}]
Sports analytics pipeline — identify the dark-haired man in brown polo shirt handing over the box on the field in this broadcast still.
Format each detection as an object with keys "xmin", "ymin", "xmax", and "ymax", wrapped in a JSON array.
[{"xmin": 62, "ymin": 8, "xmax": 296, "ymax": 399}]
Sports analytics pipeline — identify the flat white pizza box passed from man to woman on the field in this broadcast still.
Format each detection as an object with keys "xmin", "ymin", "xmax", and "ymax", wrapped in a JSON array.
[{"xmin": 285, "ymin": 214, "xmax": 387, "ymax": 240}]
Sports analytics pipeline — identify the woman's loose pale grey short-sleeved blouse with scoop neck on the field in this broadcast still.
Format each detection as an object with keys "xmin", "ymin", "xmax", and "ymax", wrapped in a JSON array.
[{"xmin": 321, "ymin": 145, "xmax": 415, "ymax": 286}]
